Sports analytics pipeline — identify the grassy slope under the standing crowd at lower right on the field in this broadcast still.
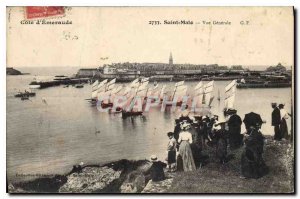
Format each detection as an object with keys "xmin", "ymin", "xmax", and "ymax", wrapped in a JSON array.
[{"xmin": 168, "ymin": 138, "xmax": 294, "ymax": 193}]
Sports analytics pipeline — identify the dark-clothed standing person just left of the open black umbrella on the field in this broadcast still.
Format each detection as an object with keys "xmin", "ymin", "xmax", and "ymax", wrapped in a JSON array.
[{"xmin": 227, "ymin": 109, "xmax": 243, "ymax": 149}]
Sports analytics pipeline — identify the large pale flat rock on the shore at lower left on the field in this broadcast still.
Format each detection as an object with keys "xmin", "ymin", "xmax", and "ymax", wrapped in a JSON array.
[{"xmin": 59, "ymin": 166, "xmax": 122, "ymax": 193}]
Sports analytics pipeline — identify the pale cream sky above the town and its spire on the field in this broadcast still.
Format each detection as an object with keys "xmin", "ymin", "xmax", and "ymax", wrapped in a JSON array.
[{"xmin": 6, "ymin": 7, "xmax": 294, "ymax": 67}]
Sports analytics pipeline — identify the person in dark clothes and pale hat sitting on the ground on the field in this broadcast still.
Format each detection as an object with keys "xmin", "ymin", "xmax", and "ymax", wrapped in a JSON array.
[{"xmin": 145, "ymin": 155, "xmax": 167, "ymax": 182}]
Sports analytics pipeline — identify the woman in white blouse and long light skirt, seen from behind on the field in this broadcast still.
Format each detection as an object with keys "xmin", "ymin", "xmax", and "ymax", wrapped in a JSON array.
[{"xmin": 178, "ymin": 123, "xmax": 196, "ymax": 171}]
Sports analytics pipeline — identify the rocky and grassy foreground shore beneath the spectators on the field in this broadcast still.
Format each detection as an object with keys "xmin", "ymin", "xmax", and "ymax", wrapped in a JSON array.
[{"xmin": 8, "ymin": 137, "xmax": 294, "ymax": 193}]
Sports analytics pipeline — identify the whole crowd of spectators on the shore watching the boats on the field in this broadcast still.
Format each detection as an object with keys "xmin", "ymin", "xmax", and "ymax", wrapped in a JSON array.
[{"xmin": 151, "ymin": 103, "xmax": 289, "ymax": 181}]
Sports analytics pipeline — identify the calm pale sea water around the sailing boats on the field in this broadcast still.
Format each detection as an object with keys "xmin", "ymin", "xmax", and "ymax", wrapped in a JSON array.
[{"xmin": 6, "ymin": 68, "xmax": 292, "ymax": 182}]
